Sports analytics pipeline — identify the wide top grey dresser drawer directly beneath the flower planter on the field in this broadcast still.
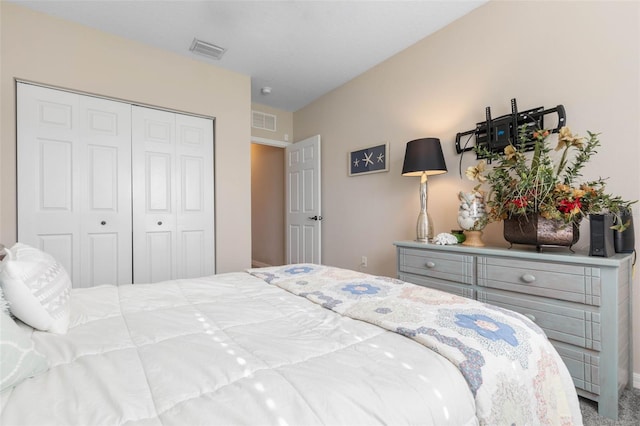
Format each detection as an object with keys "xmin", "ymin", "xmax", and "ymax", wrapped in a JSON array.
[{"xmin": 477, "ymin": 256, "xmax": 601, "ymax": 306}]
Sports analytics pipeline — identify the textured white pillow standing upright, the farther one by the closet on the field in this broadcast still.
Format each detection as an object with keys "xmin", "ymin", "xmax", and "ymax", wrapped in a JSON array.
[{"xmin": 0, "ymin": 243, "xmax": 71, "ymax": 334}]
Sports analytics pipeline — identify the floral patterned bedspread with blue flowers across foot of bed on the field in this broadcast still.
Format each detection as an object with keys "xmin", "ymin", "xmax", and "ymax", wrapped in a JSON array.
[{"xmin": 249, "ymin": 264, "xmax": 582, "ymax": 425}]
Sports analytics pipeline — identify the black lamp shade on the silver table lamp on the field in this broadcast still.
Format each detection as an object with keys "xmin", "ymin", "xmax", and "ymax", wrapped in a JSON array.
[{"xmin": 402, "ymin": 138, "xmax": 447, "ymax": 176}]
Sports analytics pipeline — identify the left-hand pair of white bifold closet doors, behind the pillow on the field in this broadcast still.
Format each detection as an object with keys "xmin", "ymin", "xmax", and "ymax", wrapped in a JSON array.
[{"xmin": 17, "ymin": 83, "xmax": 132, "ymax": 287}]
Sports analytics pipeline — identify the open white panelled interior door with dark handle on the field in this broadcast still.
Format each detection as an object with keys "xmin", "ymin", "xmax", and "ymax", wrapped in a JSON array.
[{"xmin": 285, "ymin": 135, "xmax": 322, "ymax": 264}]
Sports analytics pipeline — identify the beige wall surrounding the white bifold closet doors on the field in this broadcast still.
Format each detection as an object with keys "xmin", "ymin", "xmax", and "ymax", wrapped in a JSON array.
[{"xmin": 0, "ymin": 2, "xmax": 251, "ymax": 272}]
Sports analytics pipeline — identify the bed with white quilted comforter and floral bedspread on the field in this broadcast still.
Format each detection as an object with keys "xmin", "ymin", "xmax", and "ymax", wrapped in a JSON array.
[{"xmin": 0, "ymin": 245, "xmax": 581, "ymax": 426}]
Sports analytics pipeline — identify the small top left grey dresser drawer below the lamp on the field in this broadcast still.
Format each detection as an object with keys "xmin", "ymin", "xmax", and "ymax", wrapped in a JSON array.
[{"xmin": 398, "ymin": 248, "xmax": 475, "ymax": 285}]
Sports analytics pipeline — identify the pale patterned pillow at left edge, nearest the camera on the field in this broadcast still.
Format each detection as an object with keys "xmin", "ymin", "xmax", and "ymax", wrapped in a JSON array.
[{"xmin": 0, "ymin": 311, "xmax": 49, "ymax": 392}]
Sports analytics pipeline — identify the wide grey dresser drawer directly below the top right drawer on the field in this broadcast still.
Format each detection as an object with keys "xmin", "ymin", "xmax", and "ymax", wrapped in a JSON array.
[{"xmin": 477, "ymin": 290, "xmax": 602, "ymax": 351}]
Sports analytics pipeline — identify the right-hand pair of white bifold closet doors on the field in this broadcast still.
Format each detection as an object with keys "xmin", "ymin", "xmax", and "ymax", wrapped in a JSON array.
[{"xmin": 132, "ymin": 106, "xmax": 215, "ymax": 283}]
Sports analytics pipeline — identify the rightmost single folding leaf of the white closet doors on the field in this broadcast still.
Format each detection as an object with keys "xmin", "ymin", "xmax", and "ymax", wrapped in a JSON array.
[{"xmin": 176, "ymin": 114, "xmax": 215, "ymax": 278}]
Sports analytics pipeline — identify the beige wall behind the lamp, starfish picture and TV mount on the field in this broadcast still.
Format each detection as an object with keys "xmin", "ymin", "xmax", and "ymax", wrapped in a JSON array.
[{"xmin": 294, "ymin": 1, "xmax": 640, "ymax": 372}]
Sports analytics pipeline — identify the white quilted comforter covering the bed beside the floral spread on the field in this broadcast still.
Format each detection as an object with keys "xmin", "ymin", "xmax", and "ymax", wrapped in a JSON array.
[{"xmin": 0, "ymin": 266, "xmax": 579, "ymax": 426}]
